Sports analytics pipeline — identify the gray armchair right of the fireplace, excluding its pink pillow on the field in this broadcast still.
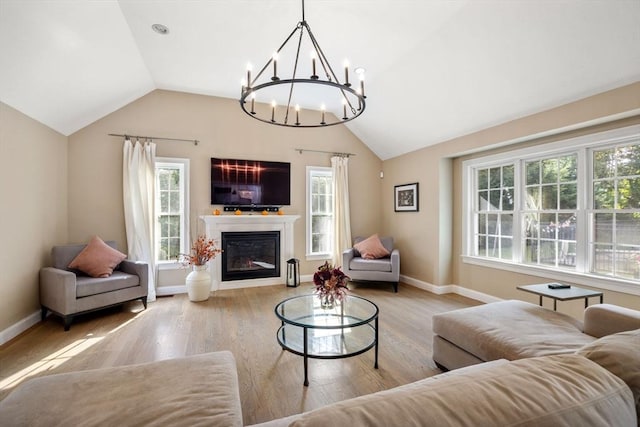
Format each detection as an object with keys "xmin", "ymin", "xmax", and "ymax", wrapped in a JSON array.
[{"xmin": 342, "ymin": 237, "xmax": 400, "ymax": 292}]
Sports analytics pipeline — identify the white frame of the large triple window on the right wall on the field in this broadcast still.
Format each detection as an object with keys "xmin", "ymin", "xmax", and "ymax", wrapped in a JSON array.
[{"xmin": 461, "ymin": 125, "xmax": 640, "ymax": 295}]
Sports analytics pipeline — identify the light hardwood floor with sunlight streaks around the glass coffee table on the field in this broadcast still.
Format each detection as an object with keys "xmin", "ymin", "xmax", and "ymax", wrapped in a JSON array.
[{"xmin": 0, "ymin": 283, "xmax": 480, "ymax": 424}]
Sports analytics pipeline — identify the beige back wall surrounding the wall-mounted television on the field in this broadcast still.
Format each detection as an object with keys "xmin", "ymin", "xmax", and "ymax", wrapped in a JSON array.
[{"xmin": 69, "ymin": 90, "xmax": 382, "ymax": 285}]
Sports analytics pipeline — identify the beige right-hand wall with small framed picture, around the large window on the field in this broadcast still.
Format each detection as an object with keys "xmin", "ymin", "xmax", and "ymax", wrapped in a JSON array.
[{"xmin": 382, "ymin": 83, "xmax": 640, "ymax": 314}]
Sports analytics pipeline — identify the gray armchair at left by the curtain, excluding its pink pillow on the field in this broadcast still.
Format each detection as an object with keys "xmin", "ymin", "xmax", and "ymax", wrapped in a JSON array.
[{"xmin": 40, "ymin": 241, "xmax": 149, "ymax": 331}]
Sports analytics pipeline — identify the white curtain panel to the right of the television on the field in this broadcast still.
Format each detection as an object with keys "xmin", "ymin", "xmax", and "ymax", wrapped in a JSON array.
[{"xmin": 331, "ymin": 156, "xmax": 353, "ymax": 266}]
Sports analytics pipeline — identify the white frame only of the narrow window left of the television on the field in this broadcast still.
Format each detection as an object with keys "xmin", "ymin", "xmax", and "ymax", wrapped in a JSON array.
[{"xmin": 154, "ymin": 157, "xmax": 191, "ymax": 270}]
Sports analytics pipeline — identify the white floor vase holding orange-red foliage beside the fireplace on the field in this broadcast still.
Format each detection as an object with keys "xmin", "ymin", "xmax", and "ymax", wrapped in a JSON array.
[{"xmin": 178, "ymin": 236, "xmax": 222, "ymax": 301}]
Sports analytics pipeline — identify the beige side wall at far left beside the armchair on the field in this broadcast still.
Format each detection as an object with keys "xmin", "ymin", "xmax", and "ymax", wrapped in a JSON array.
[{"xmin": 0, "ymin": 103, "xmax": 67, "ymax": 331}]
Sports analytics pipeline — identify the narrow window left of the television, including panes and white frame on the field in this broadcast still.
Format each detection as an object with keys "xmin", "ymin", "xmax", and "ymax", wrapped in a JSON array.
[{"xmin": 155, "ymin": 158, "xmax": 189, "ymax": 263}]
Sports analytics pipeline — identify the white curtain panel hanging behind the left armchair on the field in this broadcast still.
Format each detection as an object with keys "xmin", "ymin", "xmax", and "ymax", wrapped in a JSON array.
[{"xmin": 122, "ymin": 139, "xmax": 156, "ymax": 301}]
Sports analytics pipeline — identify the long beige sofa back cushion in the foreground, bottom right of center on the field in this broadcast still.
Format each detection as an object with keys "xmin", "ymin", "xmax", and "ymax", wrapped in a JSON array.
[{"xmin": 291, "ymin": 355, "xmax": 636, "ymax": 427}]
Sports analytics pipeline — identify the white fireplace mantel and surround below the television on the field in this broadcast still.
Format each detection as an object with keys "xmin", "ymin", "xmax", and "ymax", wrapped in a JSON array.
[{"xmin": 200, "ymin": 214, "xmax": 300, "ymax": 290}]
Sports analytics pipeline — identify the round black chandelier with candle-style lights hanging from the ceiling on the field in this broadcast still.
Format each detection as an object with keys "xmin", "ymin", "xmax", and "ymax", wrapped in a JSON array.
[{"xmin": 240, "ymin": 0, "xmax": 367, "ymax": 128}]
